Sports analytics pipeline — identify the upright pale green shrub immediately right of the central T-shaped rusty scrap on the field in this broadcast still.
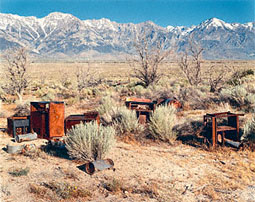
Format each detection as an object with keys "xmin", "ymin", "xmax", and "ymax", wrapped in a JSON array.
[{"xmin": 148, "ymin": 106, "xmax": 176, "ymax": 143}]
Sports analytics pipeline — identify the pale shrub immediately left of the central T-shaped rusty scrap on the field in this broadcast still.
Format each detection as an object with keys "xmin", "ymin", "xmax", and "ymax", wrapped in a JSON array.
[{"xmin": 112, "ymin": 106, "xmax": 143, "ymax": 134}]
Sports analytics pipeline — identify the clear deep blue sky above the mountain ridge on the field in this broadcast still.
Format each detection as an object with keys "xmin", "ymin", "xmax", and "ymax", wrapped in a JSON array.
[{"xmin": 0, "ymin": 0, "xmax": 255, "ymax": 26}]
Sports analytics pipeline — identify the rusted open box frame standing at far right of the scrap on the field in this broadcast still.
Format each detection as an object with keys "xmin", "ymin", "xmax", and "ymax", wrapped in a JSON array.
[{"xmin": 204, "ymin": 111, "xmax": 244, "ymax": 148}]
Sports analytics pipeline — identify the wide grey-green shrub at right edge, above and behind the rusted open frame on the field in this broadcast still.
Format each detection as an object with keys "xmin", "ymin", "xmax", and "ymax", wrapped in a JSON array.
[{"xmin": 220, "ymin": 85, "xmax": 255, "ymax": 111}]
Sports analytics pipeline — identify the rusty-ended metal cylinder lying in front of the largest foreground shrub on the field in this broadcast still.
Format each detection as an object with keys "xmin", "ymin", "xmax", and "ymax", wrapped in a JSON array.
[{"xmin": 84, "ymin": 159, "xmax": 114, "ymax": 175}]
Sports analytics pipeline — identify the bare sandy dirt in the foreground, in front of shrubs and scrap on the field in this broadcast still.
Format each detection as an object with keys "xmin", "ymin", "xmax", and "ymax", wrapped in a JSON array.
[{"xmin": 0, "ymin": 119, "xmax": 255, "ymax": 202}]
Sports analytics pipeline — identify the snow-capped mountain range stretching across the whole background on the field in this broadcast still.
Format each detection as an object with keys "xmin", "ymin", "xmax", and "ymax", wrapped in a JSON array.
[{"xmin": 0, "ymin": 12, "xmax": 255, "ymax": 59}]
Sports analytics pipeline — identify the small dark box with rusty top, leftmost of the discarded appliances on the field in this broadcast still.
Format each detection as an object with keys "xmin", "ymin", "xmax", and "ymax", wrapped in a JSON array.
[{"xmin": 7, "ymin": 116, "xmax": 30, "ymax": 138}]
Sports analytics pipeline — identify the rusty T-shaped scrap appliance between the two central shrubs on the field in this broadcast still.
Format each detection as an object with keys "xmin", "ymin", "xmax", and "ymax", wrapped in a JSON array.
[{"xmin": 125, "ymin": 98, "xmax": 156, "ymax": 124}]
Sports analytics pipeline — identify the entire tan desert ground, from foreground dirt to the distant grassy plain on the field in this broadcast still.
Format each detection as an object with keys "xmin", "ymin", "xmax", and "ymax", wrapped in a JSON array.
[{"xmin": 0, "ymin": 61, "xmax": 255, "ymax": 202}]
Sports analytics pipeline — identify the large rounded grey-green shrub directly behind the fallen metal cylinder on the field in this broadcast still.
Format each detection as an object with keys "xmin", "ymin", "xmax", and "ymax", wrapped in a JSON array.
[{"xmin": 66, "ymin": 122, "xmax": 115, "ymax": 160}]
